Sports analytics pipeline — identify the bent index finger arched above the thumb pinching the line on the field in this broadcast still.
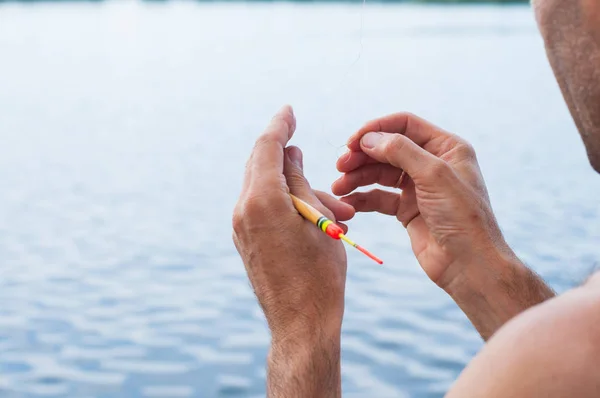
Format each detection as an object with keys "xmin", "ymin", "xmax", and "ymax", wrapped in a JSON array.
[{"xmin": 347, "ymin": 112, "xmax": 452, "ymax": 151}]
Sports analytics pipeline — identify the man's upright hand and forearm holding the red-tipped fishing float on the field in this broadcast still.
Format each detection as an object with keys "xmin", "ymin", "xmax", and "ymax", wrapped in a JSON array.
[{"xmin": 233, "ymin": 107, "xmax": 354, "ymax": 397}]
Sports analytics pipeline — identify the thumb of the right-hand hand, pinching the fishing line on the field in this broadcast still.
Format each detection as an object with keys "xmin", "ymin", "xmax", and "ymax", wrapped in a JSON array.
[{"xmin": 360, "ymin": 133, "xmax": 446, "ymax": 180}]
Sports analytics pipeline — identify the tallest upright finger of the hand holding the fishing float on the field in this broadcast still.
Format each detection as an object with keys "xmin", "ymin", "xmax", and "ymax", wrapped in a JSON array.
[{"xmin": 244, "ymin": 105, "xmax": 296, "ymax": 192}]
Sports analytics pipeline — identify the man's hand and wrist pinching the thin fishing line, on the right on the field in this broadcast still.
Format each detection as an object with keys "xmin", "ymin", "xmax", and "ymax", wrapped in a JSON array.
[{"xmin": 332, "ymin": 113, "xmax": 553, "ymax": 339}]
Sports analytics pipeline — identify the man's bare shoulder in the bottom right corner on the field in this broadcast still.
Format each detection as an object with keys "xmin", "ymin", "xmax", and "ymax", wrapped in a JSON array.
[{"xmin": 446, "ymin": 274, "xmax": 600, "ymax": 398}]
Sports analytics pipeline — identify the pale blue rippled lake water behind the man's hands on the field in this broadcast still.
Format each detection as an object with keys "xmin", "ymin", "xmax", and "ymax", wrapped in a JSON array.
[{"xmin": 0, "ymin": 1, "xmax": 600, "ymax": 398}]
